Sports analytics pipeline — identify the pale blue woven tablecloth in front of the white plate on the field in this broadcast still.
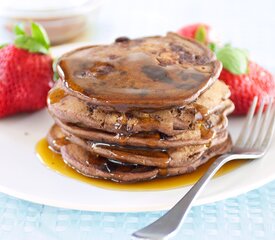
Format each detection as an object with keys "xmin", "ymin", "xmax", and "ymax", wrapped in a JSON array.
[{"xmin": 0, "ymin": 181, "xmax": 275, "ymax": 240}]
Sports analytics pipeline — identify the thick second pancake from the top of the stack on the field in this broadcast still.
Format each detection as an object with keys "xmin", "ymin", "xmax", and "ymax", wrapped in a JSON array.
[{"xmin": 48, "ymin": 81, "xmax": 232, "ymax": 136}]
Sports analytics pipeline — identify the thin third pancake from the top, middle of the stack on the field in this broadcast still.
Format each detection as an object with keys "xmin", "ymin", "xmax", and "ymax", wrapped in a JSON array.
[{"xmin": 51, "ymin": 101, "xmax": 233, "ymax": 148}]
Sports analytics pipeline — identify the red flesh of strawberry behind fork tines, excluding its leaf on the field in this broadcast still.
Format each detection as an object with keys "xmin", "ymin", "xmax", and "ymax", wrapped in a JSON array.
[{"xmin": 220, "ymin": 62, "xmax": 275, "ymax": 115}]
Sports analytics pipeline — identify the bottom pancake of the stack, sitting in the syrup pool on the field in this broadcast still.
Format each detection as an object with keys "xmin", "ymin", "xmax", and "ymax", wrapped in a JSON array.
[{"xmin": 48, "ymin": 124, "xmax": 231, "ymax": 182}]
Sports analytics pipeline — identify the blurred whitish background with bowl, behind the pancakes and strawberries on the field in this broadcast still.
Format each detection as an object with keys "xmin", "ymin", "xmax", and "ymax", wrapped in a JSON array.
[{"xmin": 0, "ymin": 0, "xmax": 275, "ymax": 67}]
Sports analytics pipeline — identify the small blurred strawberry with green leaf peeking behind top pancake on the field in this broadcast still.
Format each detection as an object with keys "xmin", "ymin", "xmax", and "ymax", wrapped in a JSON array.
[{"xmin": 178, "ymin": 23, "xmax": 210, "ymax": 44}]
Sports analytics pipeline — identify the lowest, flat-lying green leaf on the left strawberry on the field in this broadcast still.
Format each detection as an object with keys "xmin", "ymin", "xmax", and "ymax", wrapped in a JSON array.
[{"xmin": 14, "ymin": 35, "xmax": 49, "ymax": 54}]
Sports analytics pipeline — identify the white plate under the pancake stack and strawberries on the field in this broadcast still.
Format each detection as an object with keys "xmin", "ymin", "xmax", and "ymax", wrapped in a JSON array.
[{"xmin": 0, "ymin": 43, "xmax": 275, "ymax": 212}]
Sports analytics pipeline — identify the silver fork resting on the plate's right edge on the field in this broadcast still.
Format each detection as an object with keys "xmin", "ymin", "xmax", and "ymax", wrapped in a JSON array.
[{"xmin": 132, "ymin": 97, "xmax": 275, "ymax": 240}]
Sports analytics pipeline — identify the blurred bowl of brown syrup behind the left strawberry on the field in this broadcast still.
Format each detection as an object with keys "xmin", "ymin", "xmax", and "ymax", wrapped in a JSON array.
[{"xmin": 0, "ymin": 0, "xmax": 104, "ymax": 44}]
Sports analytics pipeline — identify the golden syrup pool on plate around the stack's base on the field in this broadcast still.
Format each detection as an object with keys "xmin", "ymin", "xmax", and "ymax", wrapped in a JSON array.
[{"xmin": 36, "ymin": 138, "xmax": 246, "ymax": 191}]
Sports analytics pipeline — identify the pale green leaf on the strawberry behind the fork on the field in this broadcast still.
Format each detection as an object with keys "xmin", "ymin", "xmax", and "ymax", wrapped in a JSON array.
[{"xmin": 216, "ymin": 45, "xmax": 248, "ymax": 75}]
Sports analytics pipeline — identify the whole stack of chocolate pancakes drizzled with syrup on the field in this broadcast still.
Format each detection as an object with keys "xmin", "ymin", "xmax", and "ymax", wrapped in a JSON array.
[{"xmin": 47, "ymin": 33, "xmax": 234, "ymax": 182}]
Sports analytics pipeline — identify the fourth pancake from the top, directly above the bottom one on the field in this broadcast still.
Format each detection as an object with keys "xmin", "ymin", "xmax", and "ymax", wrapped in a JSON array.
[{"xmin": 48, "ymin": 125, "xmax": 230, "ymax": 168}]
